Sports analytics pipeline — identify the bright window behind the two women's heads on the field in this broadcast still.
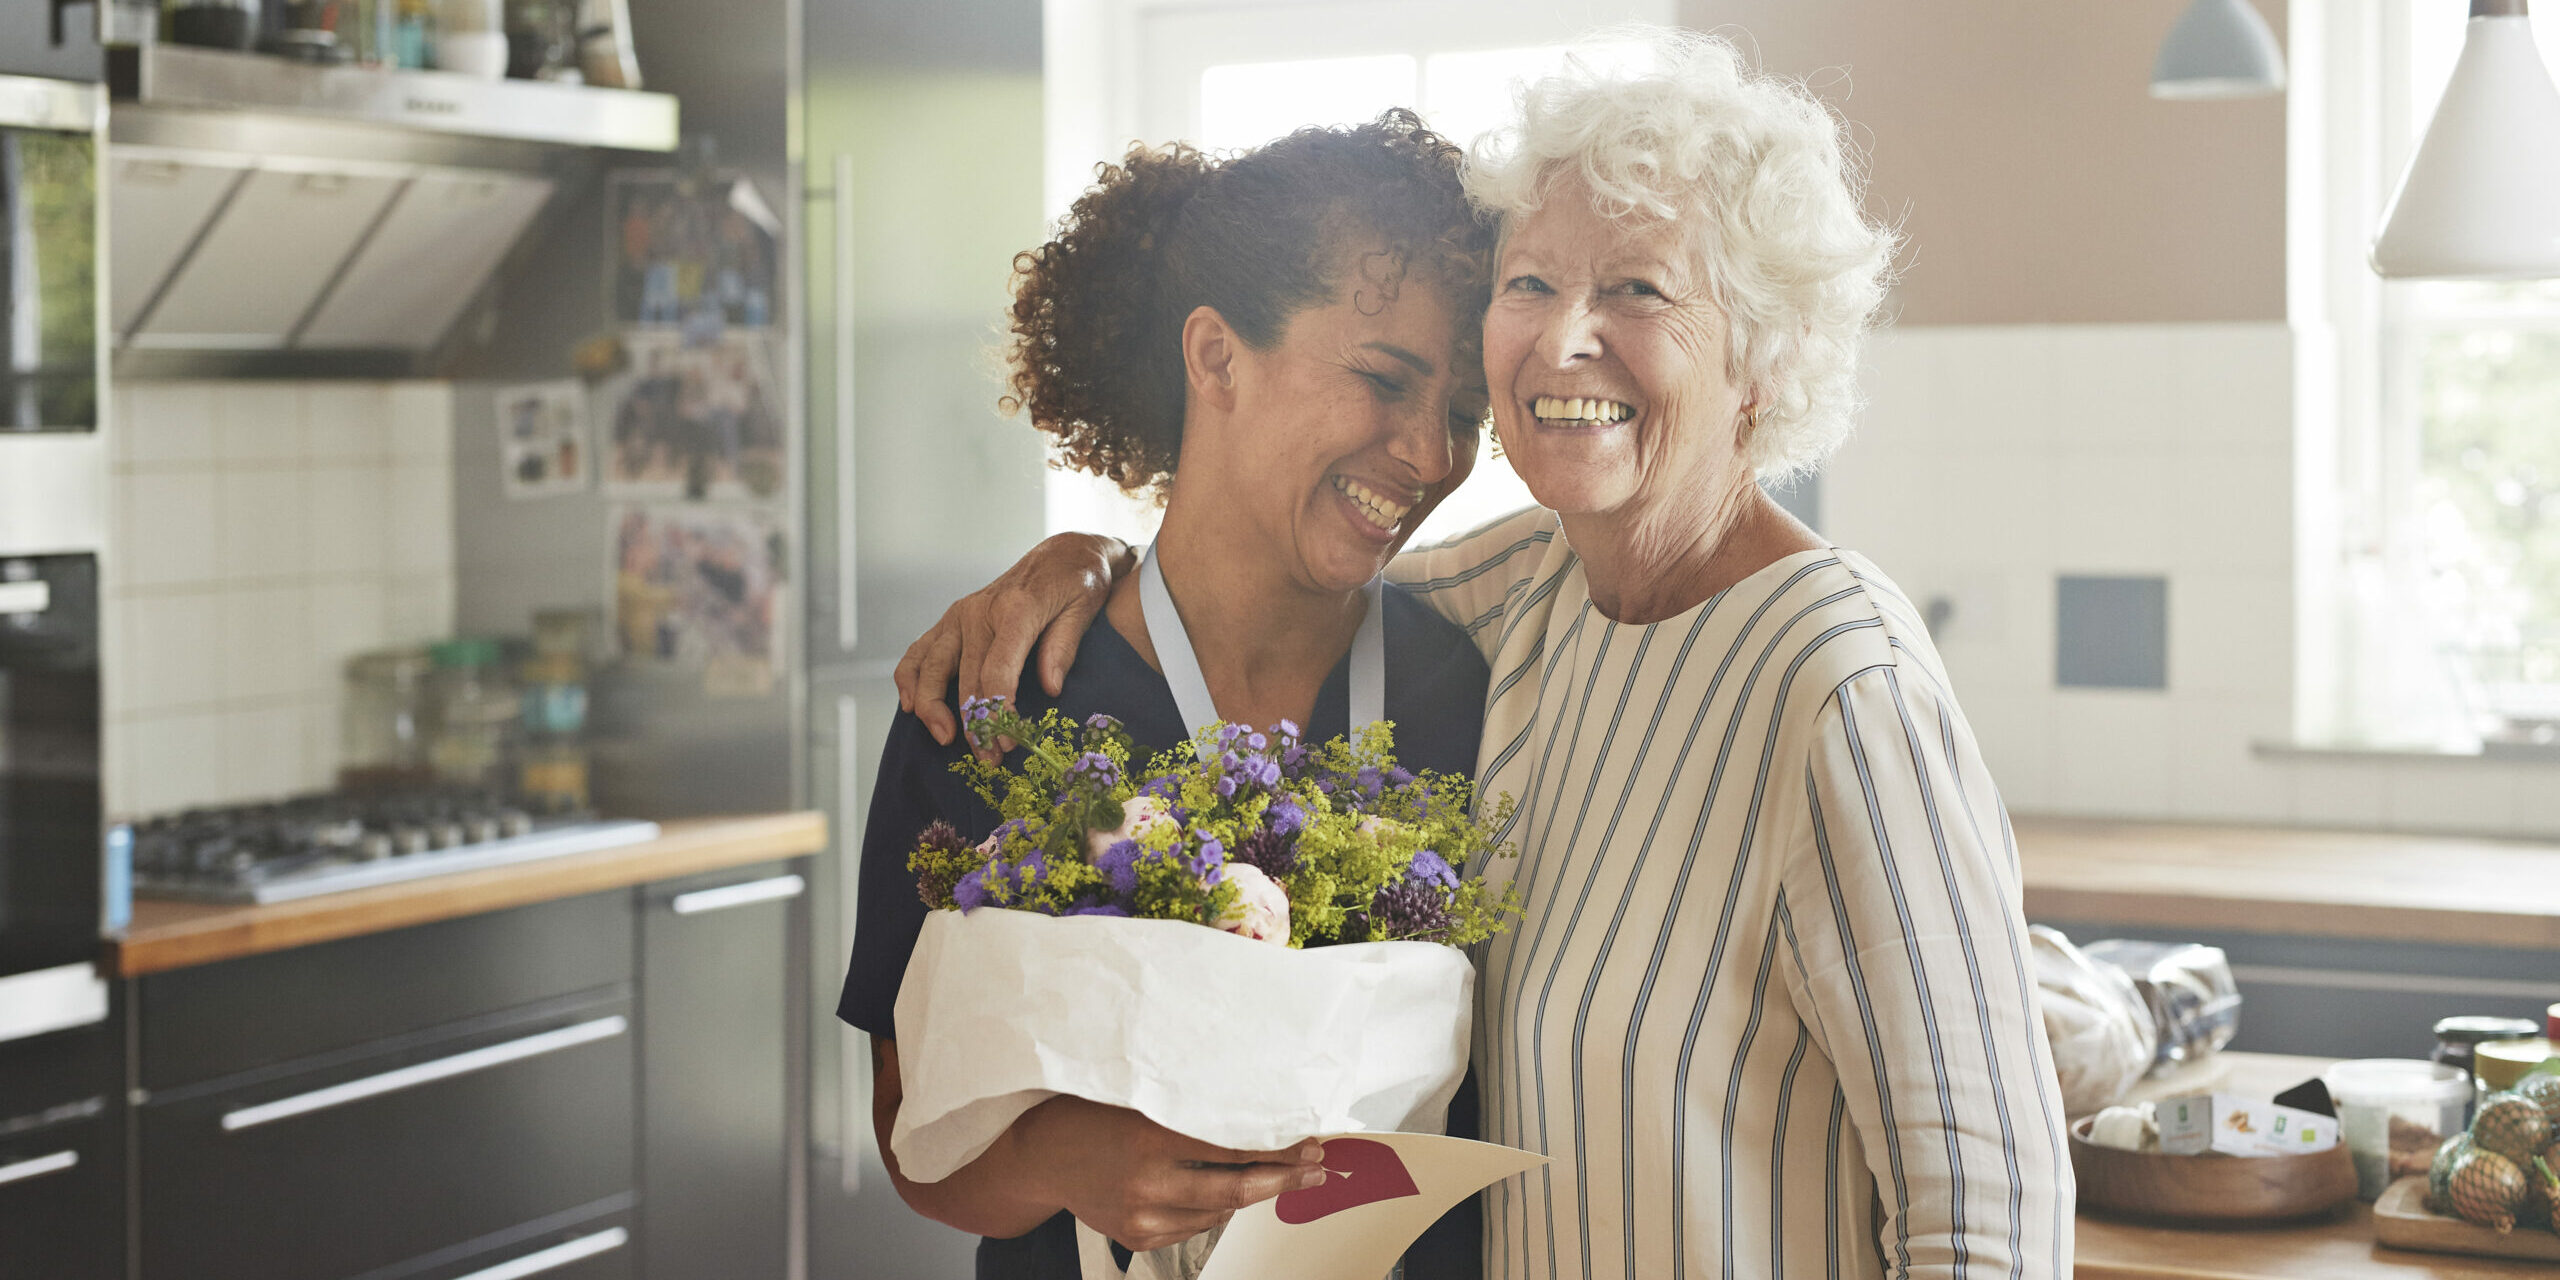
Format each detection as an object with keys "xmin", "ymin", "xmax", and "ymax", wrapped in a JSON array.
[{"xmin": 1047, "ymin": 0, "xmax": 1674, "ymax": 545}]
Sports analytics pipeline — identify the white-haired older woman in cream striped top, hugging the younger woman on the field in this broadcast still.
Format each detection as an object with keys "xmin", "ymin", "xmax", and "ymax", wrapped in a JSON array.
[{"xmin": 909, "ymin": 33, "xmax": 2071, "ymax": 1280}]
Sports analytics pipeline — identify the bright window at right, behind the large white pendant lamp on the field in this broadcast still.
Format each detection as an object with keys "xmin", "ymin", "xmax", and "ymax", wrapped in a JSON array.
[{"xmin": 2294, "ymin": 0, "xmax": 2560, "ymax": 750}]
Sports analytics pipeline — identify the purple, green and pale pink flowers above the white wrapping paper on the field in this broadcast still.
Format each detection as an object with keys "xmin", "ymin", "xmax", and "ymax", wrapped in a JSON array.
[{"xmin": 906, "ymin": 699, "xmax": 1518, "ymax": 947}]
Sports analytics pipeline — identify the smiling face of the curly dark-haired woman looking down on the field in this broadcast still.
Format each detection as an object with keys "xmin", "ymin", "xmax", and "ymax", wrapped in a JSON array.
[{"xmin": 1208, "ymin": 246, "xmax": 1485, "ymax": 591}]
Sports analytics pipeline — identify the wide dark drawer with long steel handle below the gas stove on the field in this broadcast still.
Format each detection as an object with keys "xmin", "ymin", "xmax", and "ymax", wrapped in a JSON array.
[{"xmin": 133, "ymin": 998, "xmax": 635, "ymax": 1280}]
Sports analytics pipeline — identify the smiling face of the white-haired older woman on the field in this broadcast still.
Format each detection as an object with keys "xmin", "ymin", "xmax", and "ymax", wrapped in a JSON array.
[{"xmin": 1485, "ymin": 184, "xmax": 1746, "ymax": 515}]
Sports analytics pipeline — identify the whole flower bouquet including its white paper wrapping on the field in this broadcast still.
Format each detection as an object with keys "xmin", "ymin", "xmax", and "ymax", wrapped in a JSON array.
[{"xmin": 891, "ymin": 701, "xmax": 1518, "ymax": 1228}]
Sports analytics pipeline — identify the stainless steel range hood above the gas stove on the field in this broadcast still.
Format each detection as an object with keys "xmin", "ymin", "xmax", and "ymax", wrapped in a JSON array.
[{"xmin": 105, "ymin": 46, "xmax": 676, "ymax": 374}]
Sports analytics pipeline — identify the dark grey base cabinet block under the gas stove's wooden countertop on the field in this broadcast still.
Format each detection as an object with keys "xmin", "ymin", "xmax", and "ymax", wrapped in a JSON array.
[{"xmin": 110, "ymin": 839, "xmax": 809, "ymax": 1280}]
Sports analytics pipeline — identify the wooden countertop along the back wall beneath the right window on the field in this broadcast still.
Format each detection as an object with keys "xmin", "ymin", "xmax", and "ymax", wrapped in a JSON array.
[{"xmin": 2015, "ymin": 817, "xmax": 2560, "ymax": 950}]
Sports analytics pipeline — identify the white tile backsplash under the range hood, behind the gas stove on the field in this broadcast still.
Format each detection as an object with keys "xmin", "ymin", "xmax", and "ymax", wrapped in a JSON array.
[{"xmin": 108, "ymin": 381, "xmax": 453, "ymax": 817}]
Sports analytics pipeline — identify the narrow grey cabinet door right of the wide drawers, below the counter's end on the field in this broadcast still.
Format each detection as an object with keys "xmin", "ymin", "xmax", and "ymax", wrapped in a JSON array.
[{"xmin": 640, "ymin": 863, "xmax": 806, "ymax": 1280}]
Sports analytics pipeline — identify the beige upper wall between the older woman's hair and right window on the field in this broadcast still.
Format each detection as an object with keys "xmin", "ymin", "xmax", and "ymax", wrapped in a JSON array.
[{"xmin": 1679, "ymin": 0, "xmax": 2284, "ymax": 325}]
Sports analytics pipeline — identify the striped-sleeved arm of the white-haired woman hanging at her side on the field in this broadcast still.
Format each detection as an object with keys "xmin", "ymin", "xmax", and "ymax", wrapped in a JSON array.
[{"xmin": 1779, "ymin": 660, "xmax": 2074, "ymax": 1280}]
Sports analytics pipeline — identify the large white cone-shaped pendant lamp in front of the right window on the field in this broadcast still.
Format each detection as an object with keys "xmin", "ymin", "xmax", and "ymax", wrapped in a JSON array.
[{"xmin": 2373, "ymin": 0, "xmax": 2560, "ymax": 279}]
